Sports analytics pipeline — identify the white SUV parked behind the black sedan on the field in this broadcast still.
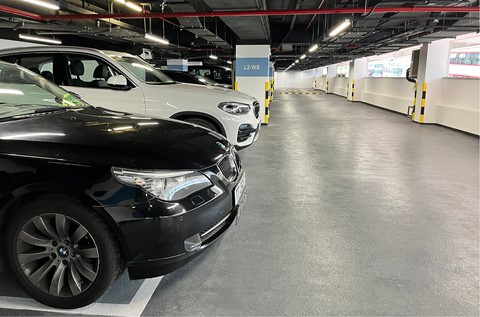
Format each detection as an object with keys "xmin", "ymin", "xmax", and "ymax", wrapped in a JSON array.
[{"xmin": 0, "ymin": 46, "xmax": 260, "ymax": 149}]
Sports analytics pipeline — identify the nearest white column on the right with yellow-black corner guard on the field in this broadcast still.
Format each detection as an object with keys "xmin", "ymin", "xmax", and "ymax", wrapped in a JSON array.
[{"xmin": 412, "ymin": 39, "xmax": 451, "ymax": 123}]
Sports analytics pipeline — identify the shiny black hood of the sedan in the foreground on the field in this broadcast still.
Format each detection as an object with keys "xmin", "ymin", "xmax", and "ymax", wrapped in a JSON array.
[{"xmin": 0, "ymin": 107, "xmax": 229, "ymax": 169}]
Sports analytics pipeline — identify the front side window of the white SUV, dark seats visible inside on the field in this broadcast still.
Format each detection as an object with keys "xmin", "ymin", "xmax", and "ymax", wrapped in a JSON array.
[{"xmin": 67, "ymin": 54, "xmax": 120, "ymax": 88}]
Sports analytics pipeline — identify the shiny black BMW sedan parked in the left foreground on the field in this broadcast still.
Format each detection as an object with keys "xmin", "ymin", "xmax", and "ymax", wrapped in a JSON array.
[{"xmin": 0, "ymin": 62, "xmax": 245, "ymax": 308}]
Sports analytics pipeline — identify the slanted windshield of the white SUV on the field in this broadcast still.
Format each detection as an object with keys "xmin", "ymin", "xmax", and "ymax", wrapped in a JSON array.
[{"xmin": 110, "ymin": 55, "xmax": 175, "ymax": 85}]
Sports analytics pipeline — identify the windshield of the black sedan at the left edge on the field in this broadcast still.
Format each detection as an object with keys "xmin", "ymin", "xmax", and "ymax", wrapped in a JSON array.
[{"xmin": 0, "ymin": 62, "xmax": 90, "ymax": 119}]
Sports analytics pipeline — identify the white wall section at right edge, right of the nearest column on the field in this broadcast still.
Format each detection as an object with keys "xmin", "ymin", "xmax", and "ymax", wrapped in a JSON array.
[{"xmin": 436, "ymin": 78, "xmax": 480, "ymax": 135}]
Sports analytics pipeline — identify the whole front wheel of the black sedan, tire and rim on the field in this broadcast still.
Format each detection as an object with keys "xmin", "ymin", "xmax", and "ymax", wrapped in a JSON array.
[{"xmin": 6, "ymin": 195, "xmax": 123, "ymax": 309}]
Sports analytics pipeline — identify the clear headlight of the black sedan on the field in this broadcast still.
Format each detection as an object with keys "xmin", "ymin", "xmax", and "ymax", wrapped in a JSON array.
[{"xmin": 112, "ymin": 167, "xmax": 213, "ymax": 201}]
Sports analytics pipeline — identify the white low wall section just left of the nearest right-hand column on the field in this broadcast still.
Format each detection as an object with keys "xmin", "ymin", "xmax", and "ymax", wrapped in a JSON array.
[{"xmin": 362, "ymin": 77, "xmax": 414, "ymax": 114}]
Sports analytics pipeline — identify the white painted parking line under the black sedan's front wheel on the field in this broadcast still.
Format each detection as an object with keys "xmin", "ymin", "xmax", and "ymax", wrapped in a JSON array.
[{"xmin": 0, "ymin": 276, "xmax": 163, "ymax": 317}]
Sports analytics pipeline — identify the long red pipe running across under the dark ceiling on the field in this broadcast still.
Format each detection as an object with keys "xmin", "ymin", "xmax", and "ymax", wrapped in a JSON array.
[{"xmin": 33, "ymin": 6, "xmax": 480, "ymax": 20}]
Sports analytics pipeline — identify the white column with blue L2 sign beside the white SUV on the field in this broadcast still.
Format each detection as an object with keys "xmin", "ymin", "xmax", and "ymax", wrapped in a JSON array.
[{"xmin": 235, "ymin": 45, "xmax": 270, "ymax": 124}]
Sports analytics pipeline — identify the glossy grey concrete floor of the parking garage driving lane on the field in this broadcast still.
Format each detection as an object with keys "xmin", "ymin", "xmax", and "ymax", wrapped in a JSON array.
[{"xmin": 0, "ymin": 90, "xmax": 479, "ymax": 316}]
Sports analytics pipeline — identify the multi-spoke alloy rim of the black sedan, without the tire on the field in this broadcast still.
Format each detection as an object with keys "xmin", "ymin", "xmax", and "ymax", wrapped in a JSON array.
[{"xmin": 16, "ymin": 213, "xmax": 100, "ymax": 297}]
